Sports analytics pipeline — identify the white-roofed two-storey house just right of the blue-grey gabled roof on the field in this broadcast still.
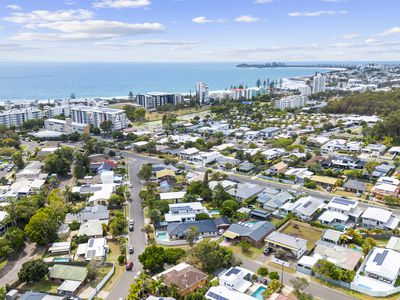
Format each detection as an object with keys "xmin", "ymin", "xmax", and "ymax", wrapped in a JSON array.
[{"xmin": 265, "ymin": 231, "xmax": 307, "ymax": 259}]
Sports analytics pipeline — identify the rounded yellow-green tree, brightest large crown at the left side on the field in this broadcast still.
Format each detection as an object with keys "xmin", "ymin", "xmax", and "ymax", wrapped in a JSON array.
[{"xmin": 24, "ymin": 207, "xmax": 59, "ymax": 245}]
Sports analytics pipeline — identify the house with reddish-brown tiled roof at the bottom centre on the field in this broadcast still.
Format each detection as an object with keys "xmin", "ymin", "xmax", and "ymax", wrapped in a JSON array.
[{"xmin": 153, "ymin": 263, "xmax": 208, "ymax": 297}]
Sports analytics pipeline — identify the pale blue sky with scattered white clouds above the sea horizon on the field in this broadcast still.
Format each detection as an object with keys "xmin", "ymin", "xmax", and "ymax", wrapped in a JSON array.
[{"xmin": 0, "ymin": 0, "xmax": 400, "ymax": 62}]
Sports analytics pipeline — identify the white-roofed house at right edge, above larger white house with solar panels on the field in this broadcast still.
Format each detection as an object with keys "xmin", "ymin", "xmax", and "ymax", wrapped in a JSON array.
[{"xmin": 361, "ymin": 207, "xmax": 400, "ymax": 230}]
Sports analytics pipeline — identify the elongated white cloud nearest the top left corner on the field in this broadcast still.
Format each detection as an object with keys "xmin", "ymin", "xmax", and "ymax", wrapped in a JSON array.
[{"xmin": 3, "ymin": 9, "xmax": 94, "ymax": 24}]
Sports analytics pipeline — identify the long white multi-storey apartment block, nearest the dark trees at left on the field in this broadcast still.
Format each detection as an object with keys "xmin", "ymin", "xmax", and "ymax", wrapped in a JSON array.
[{"xmin": 71, "ymin": 106, "xmax": 127, "ymax": 130}]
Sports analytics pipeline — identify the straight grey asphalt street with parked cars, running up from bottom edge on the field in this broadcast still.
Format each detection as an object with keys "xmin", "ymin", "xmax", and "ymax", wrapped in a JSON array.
[{"xmin": 106, "ymin": 154, "xmax": 160, "ymax": 300}]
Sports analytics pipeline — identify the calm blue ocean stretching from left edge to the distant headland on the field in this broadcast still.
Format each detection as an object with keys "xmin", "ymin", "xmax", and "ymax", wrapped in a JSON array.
[{"xmin": 0, "ymin": 63, "xmax": 329, "ymax": 101}]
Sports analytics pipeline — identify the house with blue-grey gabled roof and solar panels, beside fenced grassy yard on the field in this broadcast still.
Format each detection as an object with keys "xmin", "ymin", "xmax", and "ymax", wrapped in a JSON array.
[{"xmin": 223, "ymin": 221, "xmax": 275, "ymax": 248}]
